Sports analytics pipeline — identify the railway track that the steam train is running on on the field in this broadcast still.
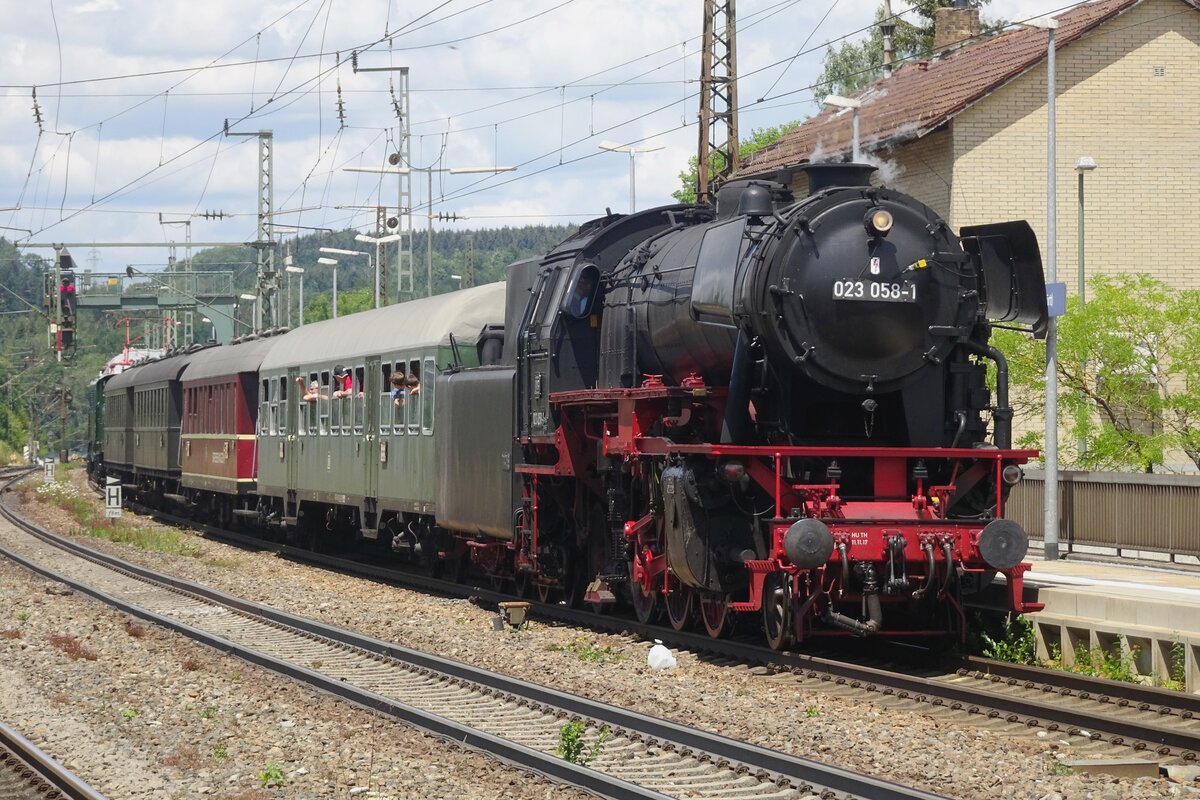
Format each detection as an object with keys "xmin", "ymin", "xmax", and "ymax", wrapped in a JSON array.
[{"xmin": 112, "ymin": 491, "xmax": 1200, "ymax": 764}]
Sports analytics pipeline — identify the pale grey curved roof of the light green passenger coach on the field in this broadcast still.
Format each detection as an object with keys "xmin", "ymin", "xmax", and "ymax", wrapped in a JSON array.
[{"xmin": 260, "ymin": 283, "xmax": 505, "ymax": 372}]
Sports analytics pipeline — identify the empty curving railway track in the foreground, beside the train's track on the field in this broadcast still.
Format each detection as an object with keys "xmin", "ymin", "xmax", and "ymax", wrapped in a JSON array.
[{"xmin": 0, "ymin": 479, "xmax": 937, "ymax": 800}]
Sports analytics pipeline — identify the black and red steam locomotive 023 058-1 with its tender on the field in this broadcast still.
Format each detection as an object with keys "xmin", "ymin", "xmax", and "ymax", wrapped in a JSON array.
[{"xmin": 439, "ymin": 164, "xmax": 1046, "ymax": 648}]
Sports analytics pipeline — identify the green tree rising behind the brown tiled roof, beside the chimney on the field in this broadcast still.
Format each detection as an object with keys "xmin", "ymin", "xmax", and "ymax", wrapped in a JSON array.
[{"xmin": 812, "ymin": 0, "xmax": 1008, "ymax": 106}]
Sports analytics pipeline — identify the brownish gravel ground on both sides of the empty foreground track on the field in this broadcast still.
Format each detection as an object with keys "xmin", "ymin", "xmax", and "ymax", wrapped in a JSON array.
[{"xmin": 0, "ymin": 471, "xmax": 1200, "ymax": 800}]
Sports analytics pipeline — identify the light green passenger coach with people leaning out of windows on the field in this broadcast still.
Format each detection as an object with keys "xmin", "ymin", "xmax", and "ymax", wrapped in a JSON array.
[{"xmin": 258, "ymin": 283, "xmax": 505, "ymax": 552}]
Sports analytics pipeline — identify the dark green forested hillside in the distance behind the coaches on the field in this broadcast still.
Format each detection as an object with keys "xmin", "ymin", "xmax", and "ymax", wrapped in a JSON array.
[{"xmin": 0, "ymin": 225, "xmax": 575, "ymax": 463}]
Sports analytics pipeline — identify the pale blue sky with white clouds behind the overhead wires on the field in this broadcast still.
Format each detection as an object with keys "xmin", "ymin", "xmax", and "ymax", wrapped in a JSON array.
[{"xmin": 0, "ymin": 0, "xmax": 1069, "ymax": 278}]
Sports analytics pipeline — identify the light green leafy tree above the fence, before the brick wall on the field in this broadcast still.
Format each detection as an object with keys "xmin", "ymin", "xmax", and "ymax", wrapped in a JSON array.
[{"xmin": 996, "ymin": 275, "xmax": 1200, "ymax": 471}]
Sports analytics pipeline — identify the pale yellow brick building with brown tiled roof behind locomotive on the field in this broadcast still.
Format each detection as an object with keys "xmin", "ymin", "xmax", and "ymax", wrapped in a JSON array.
[{"xmin": 738, "ymin": 0, "xmax": 1200, "ymax": 291}]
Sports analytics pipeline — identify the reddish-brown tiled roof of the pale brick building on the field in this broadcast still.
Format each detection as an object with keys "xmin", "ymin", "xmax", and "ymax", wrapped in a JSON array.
[{"xmin": 738, "ymin": 0, "xmax": 1185, "ymax": 178}]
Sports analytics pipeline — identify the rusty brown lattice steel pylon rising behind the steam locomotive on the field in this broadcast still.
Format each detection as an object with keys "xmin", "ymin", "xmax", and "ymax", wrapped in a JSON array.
[{"xmin": 696, "ymin": 0, "xmax": 740, "ymax": 203}]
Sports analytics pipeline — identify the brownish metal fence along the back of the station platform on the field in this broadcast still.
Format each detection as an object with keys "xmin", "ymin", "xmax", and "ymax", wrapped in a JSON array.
[{"xmin": 1004, "ymin": 469, "xmax": 1200, "ymax": 560}]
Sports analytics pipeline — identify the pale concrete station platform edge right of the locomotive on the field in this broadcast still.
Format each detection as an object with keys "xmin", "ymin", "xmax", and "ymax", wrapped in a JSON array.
[{"xmin": 1025, "ymin": 551, "xmax": 1200, "ymax": 692}]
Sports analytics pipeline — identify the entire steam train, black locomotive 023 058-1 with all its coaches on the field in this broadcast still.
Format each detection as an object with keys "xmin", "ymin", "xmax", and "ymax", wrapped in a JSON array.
[{"xmin": 90, "ymin": 164, "xmax": 1046, "ymax": 648}]
